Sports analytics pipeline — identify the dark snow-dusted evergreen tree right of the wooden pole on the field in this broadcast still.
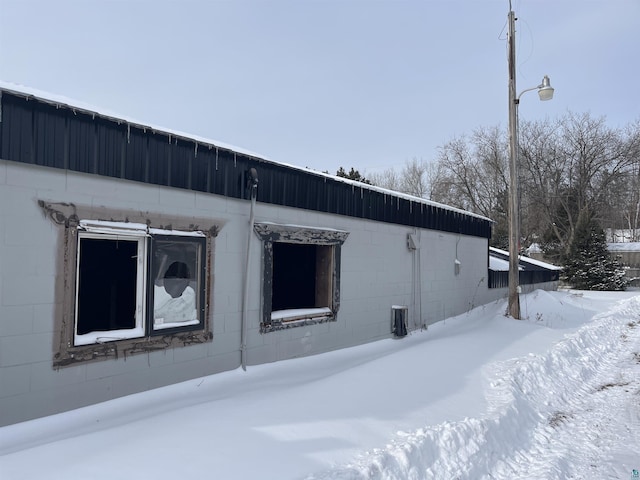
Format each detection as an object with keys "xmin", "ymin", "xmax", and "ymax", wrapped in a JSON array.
[{"xmin": 563, "ymin": 209, "xmax": 627, "ymax": 290}]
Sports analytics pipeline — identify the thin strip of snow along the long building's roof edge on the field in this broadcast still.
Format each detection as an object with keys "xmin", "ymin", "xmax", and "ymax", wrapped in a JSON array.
[{"xmin": 0, "ymin": 80, "xmax": 493, "ymax": 223}]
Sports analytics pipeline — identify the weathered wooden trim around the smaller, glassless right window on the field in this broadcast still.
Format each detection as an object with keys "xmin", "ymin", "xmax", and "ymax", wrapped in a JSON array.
[{"xmin": 254, "ymin": 222, "xmax": 349, "ymax": 333}]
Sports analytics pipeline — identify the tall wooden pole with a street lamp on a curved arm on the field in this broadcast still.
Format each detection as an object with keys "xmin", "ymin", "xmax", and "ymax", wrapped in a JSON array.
[{"xmin": 507, "ymin": 6, "xmax": 553, "ymax": 320}]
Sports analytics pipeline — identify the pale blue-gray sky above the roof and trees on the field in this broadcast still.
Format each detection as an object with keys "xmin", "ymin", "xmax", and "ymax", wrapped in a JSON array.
[{"xmin": 0, "ymin": 0, "xmax": 640, "ymax": 173}]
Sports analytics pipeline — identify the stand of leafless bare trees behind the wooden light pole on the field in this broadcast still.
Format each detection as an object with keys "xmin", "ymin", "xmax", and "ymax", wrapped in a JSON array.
[{"xmin": 362, "ymin": 112, "xmax": 640, "ymax": 255}]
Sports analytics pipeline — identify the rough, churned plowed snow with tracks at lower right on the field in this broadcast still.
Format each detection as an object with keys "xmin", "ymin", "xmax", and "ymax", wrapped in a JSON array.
[{"xmin": 309, "ymin": 297, "xmax": 640, "ymax": 480}]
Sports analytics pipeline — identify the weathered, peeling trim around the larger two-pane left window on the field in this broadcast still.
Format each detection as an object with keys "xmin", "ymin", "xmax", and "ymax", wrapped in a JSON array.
[{"xmin": 38, "ymin": 200, "xmax": 221, "ymax": 368}]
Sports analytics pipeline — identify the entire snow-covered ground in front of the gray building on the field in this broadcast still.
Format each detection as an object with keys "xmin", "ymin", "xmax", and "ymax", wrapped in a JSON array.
[{"xmin": 0, "ymin": 291, "xmax": 640, "ymax": 480}]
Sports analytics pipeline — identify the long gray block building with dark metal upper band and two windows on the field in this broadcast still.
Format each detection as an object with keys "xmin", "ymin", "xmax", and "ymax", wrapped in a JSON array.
[{"xmin": 0, "ymin": 84, "xmax": 544, "ymax": 425}]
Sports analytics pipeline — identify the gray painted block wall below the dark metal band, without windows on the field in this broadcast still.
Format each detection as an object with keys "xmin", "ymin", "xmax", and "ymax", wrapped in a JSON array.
[{"xmin": 0, "ymin": 160, "xmax": 500, "ymax": 425}]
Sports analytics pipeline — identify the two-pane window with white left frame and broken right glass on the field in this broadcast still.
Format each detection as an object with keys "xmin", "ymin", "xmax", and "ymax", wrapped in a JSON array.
[{"xmin": 73, "ymin": 222, "xmax": 206, "ymax": 346}]
